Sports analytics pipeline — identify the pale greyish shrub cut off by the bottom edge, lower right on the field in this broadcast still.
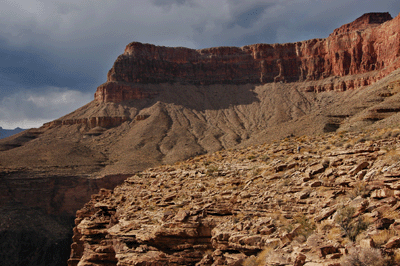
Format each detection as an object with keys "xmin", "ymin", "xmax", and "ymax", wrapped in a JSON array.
[{"xmin": 340, "ymin": 248, "xmax": 392, "ymax": 266}]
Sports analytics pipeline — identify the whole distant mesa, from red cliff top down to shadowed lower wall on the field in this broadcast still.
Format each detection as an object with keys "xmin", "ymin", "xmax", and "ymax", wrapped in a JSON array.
[{"xmin": 0, "ymin": 11, "xmax": 400, "ymax": 265}]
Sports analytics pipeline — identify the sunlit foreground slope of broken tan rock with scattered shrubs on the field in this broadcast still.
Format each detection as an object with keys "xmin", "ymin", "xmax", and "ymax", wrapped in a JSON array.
[{"xmin": 68, "ymin": 128, "xmax": 400, "ymax": 266}]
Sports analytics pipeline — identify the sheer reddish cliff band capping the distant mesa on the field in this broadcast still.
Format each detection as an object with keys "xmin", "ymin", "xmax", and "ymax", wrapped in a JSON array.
[{"xmin": 95, "ymin": 13, "xmax": 400, "ymax": 102}]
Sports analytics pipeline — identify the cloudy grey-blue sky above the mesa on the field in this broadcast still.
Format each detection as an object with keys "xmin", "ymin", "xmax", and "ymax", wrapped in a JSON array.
[{"xmin": 0, "ymin": 0, "xmax": 400, "ymax": 129}]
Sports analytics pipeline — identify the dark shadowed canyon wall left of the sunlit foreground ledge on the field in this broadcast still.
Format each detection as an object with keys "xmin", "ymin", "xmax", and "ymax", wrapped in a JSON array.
[{"xmin": 0, "ymin": 171, "xmax": 127, "ymax": 266}]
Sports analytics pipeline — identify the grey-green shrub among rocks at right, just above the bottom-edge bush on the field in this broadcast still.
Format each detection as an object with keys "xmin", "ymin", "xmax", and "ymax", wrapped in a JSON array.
[{"xmin": 335, "ymin": 206, "xmax": 369, "ymax": 242}]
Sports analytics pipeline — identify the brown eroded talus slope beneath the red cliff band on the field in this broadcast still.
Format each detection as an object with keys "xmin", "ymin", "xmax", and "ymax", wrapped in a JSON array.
[{"xmin": 0, "ymin": 71, "xmax": 400, "ymax": 176}]
